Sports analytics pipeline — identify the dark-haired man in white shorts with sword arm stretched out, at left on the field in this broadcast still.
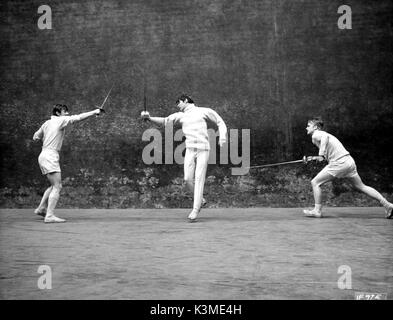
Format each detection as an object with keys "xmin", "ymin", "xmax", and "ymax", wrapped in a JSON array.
[{"xmin": 33, "ymin": 104, "xmax": 101, "ymax": 223}]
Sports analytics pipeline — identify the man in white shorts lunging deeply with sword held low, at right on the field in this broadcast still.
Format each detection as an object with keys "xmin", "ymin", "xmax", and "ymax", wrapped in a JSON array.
[{"xmin": 303, "ymin": 118, "xmax": 393, "ymax": 219}]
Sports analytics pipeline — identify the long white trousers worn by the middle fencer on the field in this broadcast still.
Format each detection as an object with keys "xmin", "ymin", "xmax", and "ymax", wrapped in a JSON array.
[{"xmin": 184, "ymin": 148, "xmax": 209, "ymax": 210}]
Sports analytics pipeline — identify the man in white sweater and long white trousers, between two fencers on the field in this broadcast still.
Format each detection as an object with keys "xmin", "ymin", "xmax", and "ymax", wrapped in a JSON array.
[{"xmin": 142, "ymin": 95, "xmax": 227, "ymax": 221}]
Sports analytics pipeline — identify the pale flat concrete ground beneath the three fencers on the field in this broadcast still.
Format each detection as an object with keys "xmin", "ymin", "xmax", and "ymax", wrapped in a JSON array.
[{"xmin": 0, "ymin": 207, "xmax": 393, "ymax": 300}]
